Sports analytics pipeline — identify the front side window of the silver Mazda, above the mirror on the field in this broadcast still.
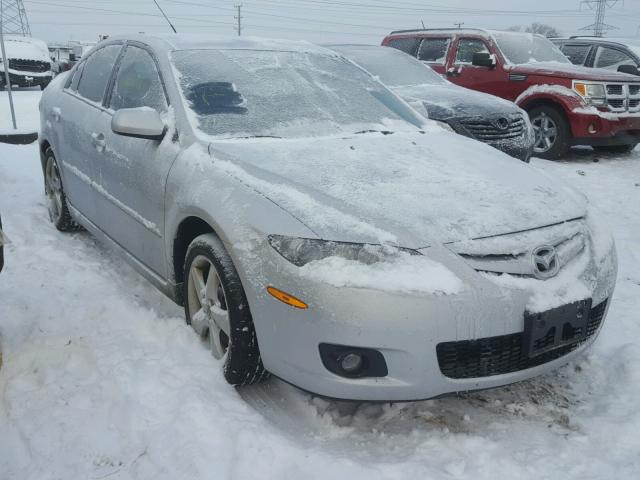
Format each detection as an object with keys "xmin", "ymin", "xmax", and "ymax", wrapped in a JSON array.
[{"xmin": 110, "ymin": 46, "xmax": 167, "ymax": 112}]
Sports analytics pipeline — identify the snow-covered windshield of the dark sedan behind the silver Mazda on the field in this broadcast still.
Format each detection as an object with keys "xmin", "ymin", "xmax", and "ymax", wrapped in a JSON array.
[{"xmin": 329, "ymin": 46, "xmax": 447, "ymax": 87}]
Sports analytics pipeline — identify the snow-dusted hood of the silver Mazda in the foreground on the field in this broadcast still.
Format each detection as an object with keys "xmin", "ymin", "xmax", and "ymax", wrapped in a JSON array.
[{"xmin": 209, "ymin": 128, "xmax": 586, "ymax": 248}]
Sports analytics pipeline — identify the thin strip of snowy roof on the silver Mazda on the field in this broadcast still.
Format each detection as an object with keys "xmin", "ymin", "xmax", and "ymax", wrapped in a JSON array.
[{"xmin": 100, "ymin": 33, "xmax": 337, "ymax": 56}]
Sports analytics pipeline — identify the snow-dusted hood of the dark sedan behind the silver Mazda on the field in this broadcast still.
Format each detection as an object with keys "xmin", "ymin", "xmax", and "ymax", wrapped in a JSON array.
[{"xmin": 392, "ymin": 85, "xmax": 520, "ymax": 122}]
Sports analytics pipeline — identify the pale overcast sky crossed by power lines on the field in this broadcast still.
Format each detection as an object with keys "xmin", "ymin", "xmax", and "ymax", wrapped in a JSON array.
[{"xmin": 16, "ymin": 0, "xmax": 640, "ymax": 43}]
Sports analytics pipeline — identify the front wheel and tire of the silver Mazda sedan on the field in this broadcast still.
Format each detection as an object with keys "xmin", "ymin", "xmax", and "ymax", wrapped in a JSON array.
[{"xmin": 183, "ymin": 233, "xmax": 269, "ymax": 386}]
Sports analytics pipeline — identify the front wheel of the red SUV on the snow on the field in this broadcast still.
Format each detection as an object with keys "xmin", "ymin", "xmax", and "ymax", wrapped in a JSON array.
[{"xmin": 529, "ymin": 106, "xmax": 571, "ymax": 160}]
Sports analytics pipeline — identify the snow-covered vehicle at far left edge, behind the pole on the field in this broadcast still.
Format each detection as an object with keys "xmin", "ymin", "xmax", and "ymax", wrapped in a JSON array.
[{"xmin": 0, "ymin": 35, "xmax": 53, "ymax": 90}]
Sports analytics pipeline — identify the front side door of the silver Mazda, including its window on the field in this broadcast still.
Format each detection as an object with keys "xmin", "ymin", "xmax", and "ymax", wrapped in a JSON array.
[{"xmin": 92, "ymin": 44, "xmax": 178, "ymax": 278}]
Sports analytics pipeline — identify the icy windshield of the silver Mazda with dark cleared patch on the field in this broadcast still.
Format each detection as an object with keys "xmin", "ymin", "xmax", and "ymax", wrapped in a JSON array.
[{"xmin": 172, "ymin": 50, "xmax": 423, "ymax": 138}]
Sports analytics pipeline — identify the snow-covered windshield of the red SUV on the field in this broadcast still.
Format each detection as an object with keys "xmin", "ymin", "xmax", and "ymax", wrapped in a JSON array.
[{"xmin": 493, "ymin": 32, "xmax": 571, "ymax": 65}]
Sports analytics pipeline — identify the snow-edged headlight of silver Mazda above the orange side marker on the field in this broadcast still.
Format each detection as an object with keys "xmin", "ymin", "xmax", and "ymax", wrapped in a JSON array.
[{"xmin": 269, "ymin": 235, "xmax": 420, "ymax": 267}]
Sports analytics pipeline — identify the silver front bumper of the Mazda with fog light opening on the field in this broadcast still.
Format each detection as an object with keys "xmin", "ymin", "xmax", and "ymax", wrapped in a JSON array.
[{"xmin": 234, "ymin": 232, "xmax": 615, "ymax": 401}]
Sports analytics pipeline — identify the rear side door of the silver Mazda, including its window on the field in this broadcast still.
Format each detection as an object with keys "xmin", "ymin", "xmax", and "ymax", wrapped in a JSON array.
[{"xmin": 57, "ymin": 44, "xmax": 122, "ymax": 222}]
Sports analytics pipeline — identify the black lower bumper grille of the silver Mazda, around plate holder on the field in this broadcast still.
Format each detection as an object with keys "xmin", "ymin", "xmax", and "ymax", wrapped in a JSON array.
[{"xmin": 436, "ymin": 300, "xmax": 607, "ymax": 379}]
